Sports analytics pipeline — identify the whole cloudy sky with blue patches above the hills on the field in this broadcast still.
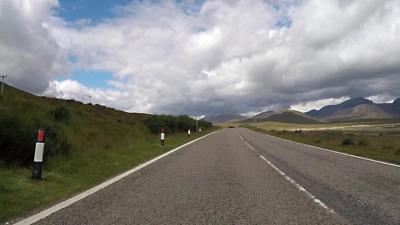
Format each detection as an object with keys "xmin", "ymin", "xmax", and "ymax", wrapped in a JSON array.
[{"xmin": 0, "ymin": 0, "xmax": 400, "ymax": 115}]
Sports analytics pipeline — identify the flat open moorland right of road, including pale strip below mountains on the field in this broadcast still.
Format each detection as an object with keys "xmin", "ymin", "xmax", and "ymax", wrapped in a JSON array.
[{"xmin": 241, "ymin": 121, "xmax": 400, "ymax": 164}]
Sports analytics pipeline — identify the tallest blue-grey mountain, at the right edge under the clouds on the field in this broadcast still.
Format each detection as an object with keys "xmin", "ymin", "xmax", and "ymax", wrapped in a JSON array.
[{"xmin": 305, "ymin": 98, "xmax": 400, "ymax": 120}]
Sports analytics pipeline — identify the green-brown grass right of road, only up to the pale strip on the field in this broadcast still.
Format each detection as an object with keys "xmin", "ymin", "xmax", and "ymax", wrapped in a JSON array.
[{"xmin": 247, "ymin": 125, "xmax": 400, "ymax": 164}]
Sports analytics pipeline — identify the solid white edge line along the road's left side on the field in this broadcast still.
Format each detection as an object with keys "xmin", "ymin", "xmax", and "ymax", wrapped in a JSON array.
[{"xmin": 15, "ymin": 131, "xmax": 217, "ymax": 225}]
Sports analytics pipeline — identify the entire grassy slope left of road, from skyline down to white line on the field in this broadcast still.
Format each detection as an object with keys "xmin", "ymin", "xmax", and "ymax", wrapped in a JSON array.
[{"xmin": 0, "ymin": 83, "xmax": 216, "ymax": 222}]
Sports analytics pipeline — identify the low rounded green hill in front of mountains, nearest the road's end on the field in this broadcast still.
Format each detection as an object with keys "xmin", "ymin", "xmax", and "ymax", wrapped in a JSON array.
[{"xmin": 240, "ymin": 110, "xmax": 323, "ymax": 124}]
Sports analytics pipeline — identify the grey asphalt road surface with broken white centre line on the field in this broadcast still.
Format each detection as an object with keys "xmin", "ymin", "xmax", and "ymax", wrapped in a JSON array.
[{"xmin": 32, "ymin": 128, "xmax": 400, "ymax": 225}]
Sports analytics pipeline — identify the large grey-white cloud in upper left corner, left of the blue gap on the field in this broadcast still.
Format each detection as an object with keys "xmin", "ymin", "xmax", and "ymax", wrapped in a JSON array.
[{"xmin": 0, "ymin": 0, "xmax": 68, "ymax": 93}]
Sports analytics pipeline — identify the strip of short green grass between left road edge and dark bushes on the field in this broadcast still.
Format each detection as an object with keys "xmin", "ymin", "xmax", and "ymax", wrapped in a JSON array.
[{"xmin": 0, "ymin": 128, "xmax": 217, "ymax": 222}]
